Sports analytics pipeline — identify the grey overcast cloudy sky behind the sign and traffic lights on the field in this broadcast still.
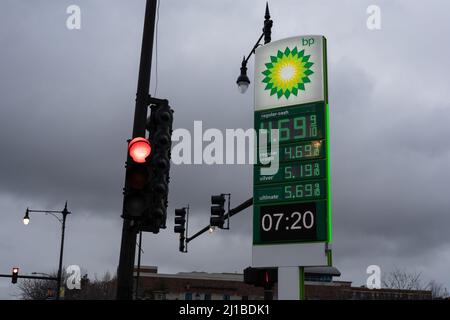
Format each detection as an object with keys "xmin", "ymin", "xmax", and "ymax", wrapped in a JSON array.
[{"xmin": 0, "ymin": 0, "xmax": 450, "ymax": 299}]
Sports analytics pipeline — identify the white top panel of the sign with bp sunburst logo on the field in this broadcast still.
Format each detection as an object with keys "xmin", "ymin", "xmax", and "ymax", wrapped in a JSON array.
[{"xmin": 254, "ymin": 35, "xmax": 326, "ymax": 110}]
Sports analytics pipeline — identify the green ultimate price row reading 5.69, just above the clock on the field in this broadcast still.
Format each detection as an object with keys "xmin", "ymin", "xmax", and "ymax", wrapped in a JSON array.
[{"xmin": 254, "ymin": 180, "xmax": 326, "ymax": 203}]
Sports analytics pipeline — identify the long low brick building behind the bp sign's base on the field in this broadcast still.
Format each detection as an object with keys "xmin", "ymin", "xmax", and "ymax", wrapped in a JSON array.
[{"xmin": 135, "ymin": 267, "xmax": 431, "ymax": 300}]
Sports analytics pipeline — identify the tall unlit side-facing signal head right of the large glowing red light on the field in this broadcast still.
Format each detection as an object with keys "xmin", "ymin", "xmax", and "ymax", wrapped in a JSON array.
[{"xmin": 141, "ymin": 100, "xmax": 173, "ymax": 233}]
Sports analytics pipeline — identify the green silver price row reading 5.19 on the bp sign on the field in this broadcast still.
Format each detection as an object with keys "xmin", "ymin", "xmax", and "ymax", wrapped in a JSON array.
[{"xmin": 254, "ymin": 160, "xmax": 325, "ymax": 184}]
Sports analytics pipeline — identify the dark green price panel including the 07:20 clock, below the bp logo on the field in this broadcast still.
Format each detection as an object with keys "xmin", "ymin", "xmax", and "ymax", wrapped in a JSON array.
[{"xmin": 253, "ymin": 101, "xmax": 330, "ymax": 244}]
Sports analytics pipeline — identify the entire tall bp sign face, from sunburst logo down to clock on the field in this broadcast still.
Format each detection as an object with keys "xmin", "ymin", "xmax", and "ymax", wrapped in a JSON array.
[{"xmin": 253, "ymin": 36, "xmax": 331, "ymax": 258}]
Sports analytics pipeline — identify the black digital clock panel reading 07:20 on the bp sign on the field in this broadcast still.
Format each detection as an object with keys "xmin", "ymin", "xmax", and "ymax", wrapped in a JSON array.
[{"xmin": 257, "ymin": 202, "xmax": 326, "ymax": 243}]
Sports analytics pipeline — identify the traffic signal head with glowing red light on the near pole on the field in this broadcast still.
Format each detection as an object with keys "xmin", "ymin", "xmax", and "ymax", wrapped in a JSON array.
[{"xmin": 123, "ymin": 137, "xmax": 152, "ymax": 220}]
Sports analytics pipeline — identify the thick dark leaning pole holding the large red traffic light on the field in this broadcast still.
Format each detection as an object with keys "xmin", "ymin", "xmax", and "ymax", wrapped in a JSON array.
[{"xmin": 116, "ymin": 0, "xmax": 157, "ymax": 300}]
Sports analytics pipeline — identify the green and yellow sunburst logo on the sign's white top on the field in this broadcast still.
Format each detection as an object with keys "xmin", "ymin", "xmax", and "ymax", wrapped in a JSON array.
[{"xmin": 262, "ymin": 47, "xmax": 314, "ymax": 99}]
